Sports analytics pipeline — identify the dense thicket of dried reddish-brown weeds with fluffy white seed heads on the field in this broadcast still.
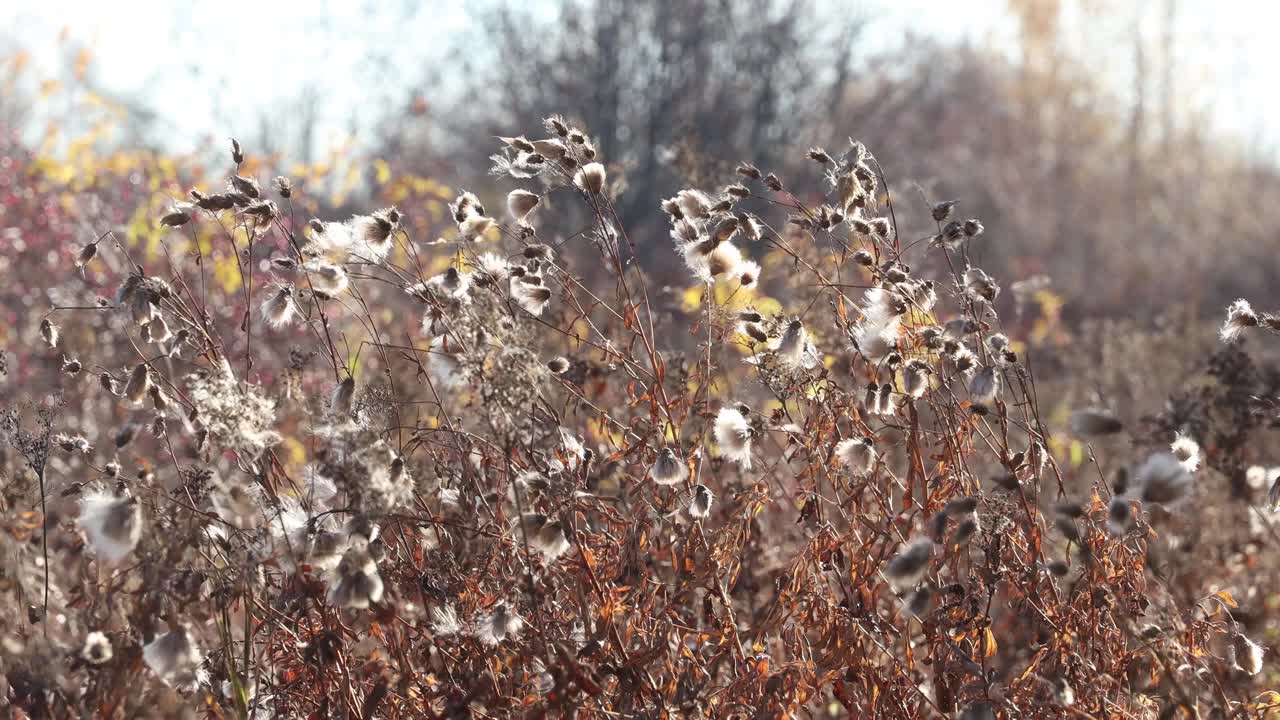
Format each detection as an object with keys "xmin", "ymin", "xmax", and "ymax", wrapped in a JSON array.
[{"xmin": 0, "ymin": 118, "xmax": 1280, "ymax": 720}]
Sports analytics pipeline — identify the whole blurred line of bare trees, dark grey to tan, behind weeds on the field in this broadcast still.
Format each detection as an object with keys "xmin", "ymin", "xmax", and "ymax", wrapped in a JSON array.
[{"xmin": 381, "ymin": 0, "xmax": 1280, "ymax": 320}]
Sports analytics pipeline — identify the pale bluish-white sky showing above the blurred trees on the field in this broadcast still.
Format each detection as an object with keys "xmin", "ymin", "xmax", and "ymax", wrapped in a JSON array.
[{"xmin": 0, "ymin": 0, "xmax": 1280, "ymax": 156}]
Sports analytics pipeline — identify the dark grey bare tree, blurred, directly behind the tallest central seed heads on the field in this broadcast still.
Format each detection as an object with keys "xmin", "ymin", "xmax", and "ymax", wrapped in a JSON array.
[{"xmin": 435, "ymin": 0, "xmax": 864, "ymax": 222}]
